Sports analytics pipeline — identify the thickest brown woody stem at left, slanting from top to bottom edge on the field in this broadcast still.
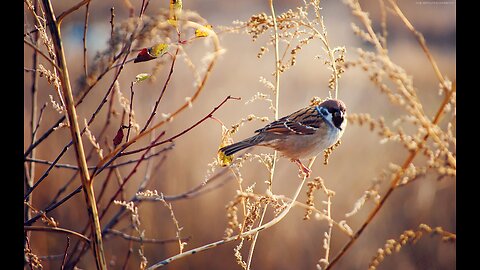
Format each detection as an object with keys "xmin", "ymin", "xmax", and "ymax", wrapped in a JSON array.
[{"xmin": 43, "ymin": 0, "xmax": 107, "ymax": 269}]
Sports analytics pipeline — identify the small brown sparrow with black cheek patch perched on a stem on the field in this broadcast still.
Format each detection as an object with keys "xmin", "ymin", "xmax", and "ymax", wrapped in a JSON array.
[{"xmin": 219, "ymin": 99, "xmax": 347, "ymax": 177}]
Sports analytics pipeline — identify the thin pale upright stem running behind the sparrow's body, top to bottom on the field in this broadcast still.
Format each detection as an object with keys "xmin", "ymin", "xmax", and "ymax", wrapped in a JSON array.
[{"xmin": 247, "ymin": 0, "xmax": 280, "ymax": 269}]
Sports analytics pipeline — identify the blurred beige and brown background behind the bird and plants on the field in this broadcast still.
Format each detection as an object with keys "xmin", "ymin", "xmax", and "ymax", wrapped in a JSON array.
[{"xmin": 24, "ymin": 0, "xmax": 456, "ymax": 269}]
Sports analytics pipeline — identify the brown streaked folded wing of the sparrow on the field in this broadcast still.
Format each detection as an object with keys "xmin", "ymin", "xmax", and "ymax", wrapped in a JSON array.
[{"xmin": 255, "ymin": 106, "xmax": 325, "ymax": 135}]
